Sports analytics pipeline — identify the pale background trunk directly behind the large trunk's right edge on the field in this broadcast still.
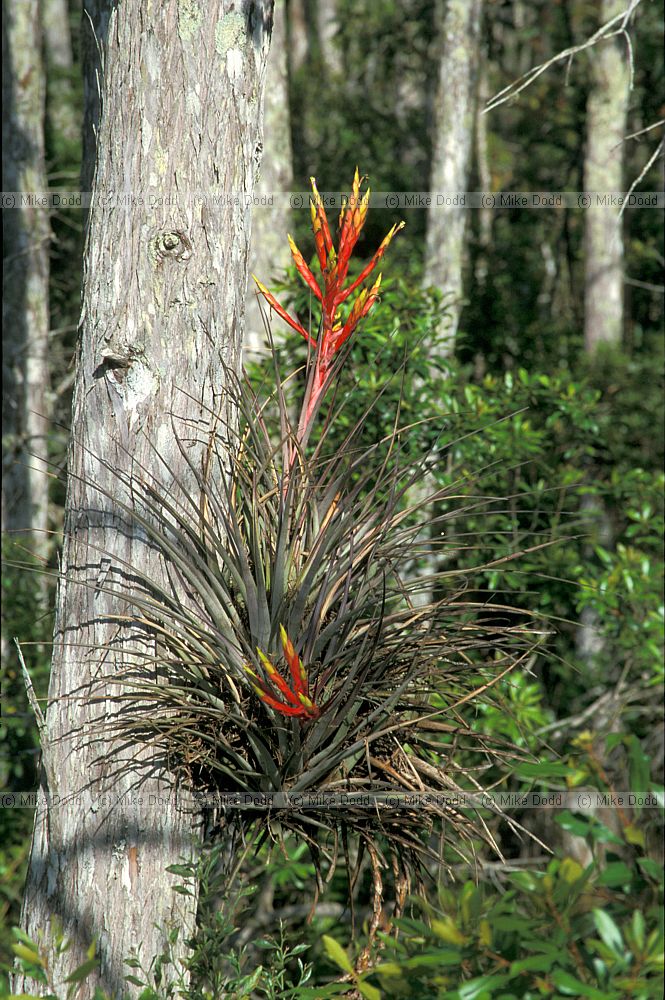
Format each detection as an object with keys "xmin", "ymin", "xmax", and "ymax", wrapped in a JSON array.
[{"xmin": 243, "ymin": 0, "xmax": 293, "ymax": 360}]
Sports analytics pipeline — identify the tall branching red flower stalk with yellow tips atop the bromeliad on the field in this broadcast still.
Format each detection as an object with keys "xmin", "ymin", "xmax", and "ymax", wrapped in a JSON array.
[{"xmin": 254, "ymin": 167, "xmax": 405, "ymax": 447}]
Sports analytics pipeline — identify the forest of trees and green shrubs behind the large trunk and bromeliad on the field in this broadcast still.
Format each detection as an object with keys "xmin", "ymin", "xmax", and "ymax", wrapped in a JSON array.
[{"xmin": 0, "ymin": 0, "xmax": 665, "ymax": 1000}]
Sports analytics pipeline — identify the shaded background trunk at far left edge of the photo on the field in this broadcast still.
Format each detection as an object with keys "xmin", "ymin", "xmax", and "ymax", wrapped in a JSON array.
[{"xmin": 2, "ymin": 0, "xmax": 51, "ymax": 555}]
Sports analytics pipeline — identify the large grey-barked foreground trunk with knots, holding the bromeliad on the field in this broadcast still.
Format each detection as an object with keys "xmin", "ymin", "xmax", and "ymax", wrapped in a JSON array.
[{"xmin": 15, "ymin": 0, "xmax": 272, "ymax": 998}]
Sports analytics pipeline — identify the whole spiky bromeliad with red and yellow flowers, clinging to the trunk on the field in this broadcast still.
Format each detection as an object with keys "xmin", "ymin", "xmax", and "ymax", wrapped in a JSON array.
[{"xmin": 58, "ymin": 172, "xmax": 537, "ymax": 936}]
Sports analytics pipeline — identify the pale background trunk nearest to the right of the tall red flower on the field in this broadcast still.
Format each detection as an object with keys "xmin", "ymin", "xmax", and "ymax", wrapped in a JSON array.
[{"xmin": 425, "ymin": 0, "xmax": 483, "ymax": 354}]
